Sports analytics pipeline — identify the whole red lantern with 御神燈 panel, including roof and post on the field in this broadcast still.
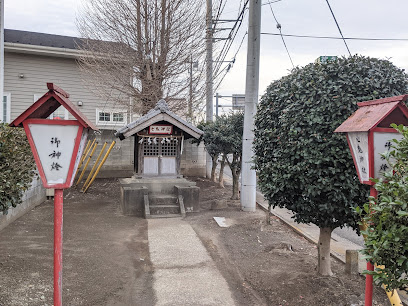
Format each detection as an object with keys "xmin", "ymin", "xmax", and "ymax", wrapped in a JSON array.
[{"xmin": 10, "ymin": 83, "xmax": 96, "ymax": 306}]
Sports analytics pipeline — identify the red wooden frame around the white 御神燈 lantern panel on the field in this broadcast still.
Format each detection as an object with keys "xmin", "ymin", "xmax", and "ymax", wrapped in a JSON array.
[{"xmin": 23, "ymin": 119, "xmax": 84, "ymax": 189}]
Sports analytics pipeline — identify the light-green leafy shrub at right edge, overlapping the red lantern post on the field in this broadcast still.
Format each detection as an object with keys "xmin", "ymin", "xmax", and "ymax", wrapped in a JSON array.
[{"xmin": 357, "ymin": 124, "xmax": 408, "ymax": 292}]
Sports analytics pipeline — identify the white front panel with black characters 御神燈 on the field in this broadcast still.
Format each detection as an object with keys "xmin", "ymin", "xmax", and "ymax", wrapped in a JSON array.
[{"xmin": 28, "ymin": 124, "xmax": 79, "ymax": 185}]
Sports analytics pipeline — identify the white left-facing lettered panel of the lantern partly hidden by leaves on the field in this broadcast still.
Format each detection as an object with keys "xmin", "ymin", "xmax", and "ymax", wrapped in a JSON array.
[{"xmin": 348, "ymin": 132, "xmax": 370, "ymax": 182}]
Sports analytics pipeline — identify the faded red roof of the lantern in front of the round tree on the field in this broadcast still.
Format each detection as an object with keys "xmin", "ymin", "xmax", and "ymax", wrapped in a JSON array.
[{"xmin": 334, "ymin": 95, "xmax": 408, "ymax": 133}]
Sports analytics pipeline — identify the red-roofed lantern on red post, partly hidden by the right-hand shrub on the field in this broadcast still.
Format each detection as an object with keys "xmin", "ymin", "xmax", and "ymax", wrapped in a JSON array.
[{"xmin": 334, "ymin": 95, "xmax": 408, "ymax": 306}]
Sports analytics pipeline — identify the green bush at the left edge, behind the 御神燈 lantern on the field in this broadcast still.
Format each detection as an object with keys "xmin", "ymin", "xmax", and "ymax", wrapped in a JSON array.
[{"xmin": 0, "ymin": 123, "xmax": 35, "ymax": 214}]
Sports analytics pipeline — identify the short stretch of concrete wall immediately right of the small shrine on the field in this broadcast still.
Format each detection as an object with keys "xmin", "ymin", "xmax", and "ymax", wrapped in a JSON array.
[{"xmin": 180, "ymin": 139, "xmax": 206, "ymax": 177}]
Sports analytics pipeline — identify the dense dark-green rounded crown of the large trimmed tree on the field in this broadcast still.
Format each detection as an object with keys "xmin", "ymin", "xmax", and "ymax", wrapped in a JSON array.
[{"xmin": 254, "ymin": 55, "xmax": 408, "ymax": 229}]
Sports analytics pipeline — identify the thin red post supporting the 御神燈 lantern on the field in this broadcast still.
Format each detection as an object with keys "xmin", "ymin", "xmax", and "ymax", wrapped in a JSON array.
[{"xmin": 54, "ymin": 189, "xmax": 64, "ymax": 306}]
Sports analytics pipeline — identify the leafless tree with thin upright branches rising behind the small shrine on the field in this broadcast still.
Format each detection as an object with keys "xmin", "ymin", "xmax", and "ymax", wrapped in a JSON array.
[{"xmin": 77, "ymin": 0, "xmax": 205, "ymax": 114}]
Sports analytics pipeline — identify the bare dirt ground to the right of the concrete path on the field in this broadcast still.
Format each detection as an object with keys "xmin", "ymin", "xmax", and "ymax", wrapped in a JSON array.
[{"xmin": 186, "ymin": 179, "xmax": 389, "ymax": 306}]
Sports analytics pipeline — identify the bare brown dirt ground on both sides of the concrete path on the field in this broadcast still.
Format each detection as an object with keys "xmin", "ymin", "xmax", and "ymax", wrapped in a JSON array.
[{"xmin": 0, "ymin": 179, "xmax": 389, "ymax": 306}]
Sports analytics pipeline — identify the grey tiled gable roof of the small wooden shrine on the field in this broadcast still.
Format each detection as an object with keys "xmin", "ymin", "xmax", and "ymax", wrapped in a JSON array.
[{"xmin": 115, "ymin": 99, "xmax": 204, "ymax": 139}]
